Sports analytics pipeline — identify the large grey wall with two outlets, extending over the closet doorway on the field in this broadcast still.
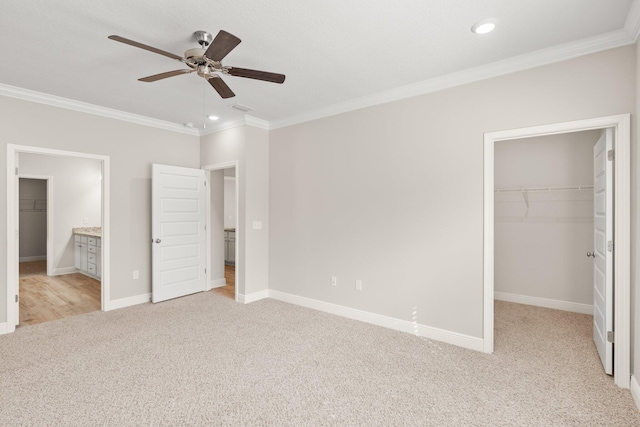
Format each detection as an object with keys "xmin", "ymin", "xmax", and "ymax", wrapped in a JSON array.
[{"xmin": 269, "ymin": 46, "xmax": 636, "ymax": 337}]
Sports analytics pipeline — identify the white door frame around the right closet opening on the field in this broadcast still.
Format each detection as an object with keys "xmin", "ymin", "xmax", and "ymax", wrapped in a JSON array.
[{"xmin": 483, "ymin": 114, "xmax": 631, "ymax": 389}]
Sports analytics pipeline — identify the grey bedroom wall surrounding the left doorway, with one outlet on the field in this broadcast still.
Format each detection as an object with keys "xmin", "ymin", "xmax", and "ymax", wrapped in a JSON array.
[{"xmin": 0, "ymin": 97, "xmax": 199, "ymax": 323}]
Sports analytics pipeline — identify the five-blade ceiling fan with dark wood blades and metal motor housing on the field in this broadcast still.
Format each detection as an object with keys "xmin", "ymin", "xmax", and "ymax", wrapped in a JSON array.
[{"xmin": 109, "ymin": 30, "xmax": 285, "ymax": 98}]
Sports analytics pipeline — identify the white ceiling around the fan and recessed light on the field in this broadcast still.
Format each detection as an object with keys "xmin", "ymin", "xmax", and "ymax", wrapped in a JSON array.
[{"xmin": 0, "ymin": 0, "xmax": 640, "ymax": 132}]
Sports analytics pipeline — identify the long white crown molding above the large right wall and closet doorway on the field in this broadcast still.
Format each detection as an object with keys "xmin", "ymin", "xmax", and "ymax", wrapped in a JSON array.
[{"xmin": 269, "ymin": 28, "xmax": 640, "ymax": 130}]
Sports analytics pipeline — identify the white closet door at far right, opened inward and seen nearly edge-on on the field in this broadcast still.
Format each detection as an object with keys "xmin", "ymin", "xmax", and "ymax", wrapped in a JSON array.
[{"xmin": 592, "ymin": 128, "xmax": 614, "ymax": 375}]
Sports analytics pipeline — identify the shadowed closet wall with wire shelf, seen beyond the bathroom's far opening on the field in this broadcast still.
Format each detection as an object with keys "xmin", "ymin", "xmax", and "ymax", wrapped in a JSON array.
[{"xmin": 18, "ymin": 178, "xmax": 47, "ymax": 261}]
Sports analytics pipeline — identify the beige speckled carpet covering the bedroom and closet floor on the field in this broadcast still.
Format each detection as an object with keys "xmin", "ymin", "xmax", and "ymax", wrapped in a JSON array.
[{"xmin": 0, "ymin": 292, "xmax": 640, "ymax": 426}]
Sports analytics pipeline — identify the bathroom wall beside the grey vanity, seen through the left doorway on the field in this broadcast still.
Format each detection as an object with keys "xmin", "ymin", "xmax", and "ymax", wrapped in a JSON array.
[{"xmin": 18, "ymin": 153, "xmax": 102, "ymax": 275}]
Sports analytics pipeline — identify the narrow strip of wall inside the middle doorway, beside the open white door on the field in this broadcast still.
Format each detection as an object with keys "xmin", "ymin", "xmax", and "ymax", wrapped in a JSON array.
[{"xmin": 209, "ymin": 170, "xmax": 226, "ymax": 286}]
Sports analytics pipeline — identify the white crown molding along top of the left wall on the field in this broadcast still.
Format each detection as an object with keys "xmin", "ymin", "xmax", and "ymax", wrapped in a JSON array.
[{"xmin": 0, "ymin": 84, "xmax": 200, "ymax": 136}]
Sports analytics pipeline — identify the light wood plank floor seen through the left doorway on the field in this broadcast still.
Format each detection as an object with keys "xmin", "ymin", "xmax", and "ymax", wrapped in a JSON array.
[{"xmin": 19, "ymin": 261, "xmax": 102, "ymax": 326}]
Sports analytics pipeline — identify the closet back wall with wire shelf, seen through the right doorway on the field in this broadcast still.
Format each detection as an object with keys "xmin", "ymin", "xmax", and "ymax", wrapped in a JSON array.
[{"xmin": 494, "ymin": 131, "xmax": 601, "ymax": 310}]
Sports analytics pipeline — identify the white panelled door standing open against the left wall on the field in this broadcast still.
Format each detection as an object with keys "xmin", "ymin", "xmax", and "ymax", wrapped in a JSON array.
[{"xmin": 151, "ymin": 164, "xmax": 206, "ymax": 303}]
